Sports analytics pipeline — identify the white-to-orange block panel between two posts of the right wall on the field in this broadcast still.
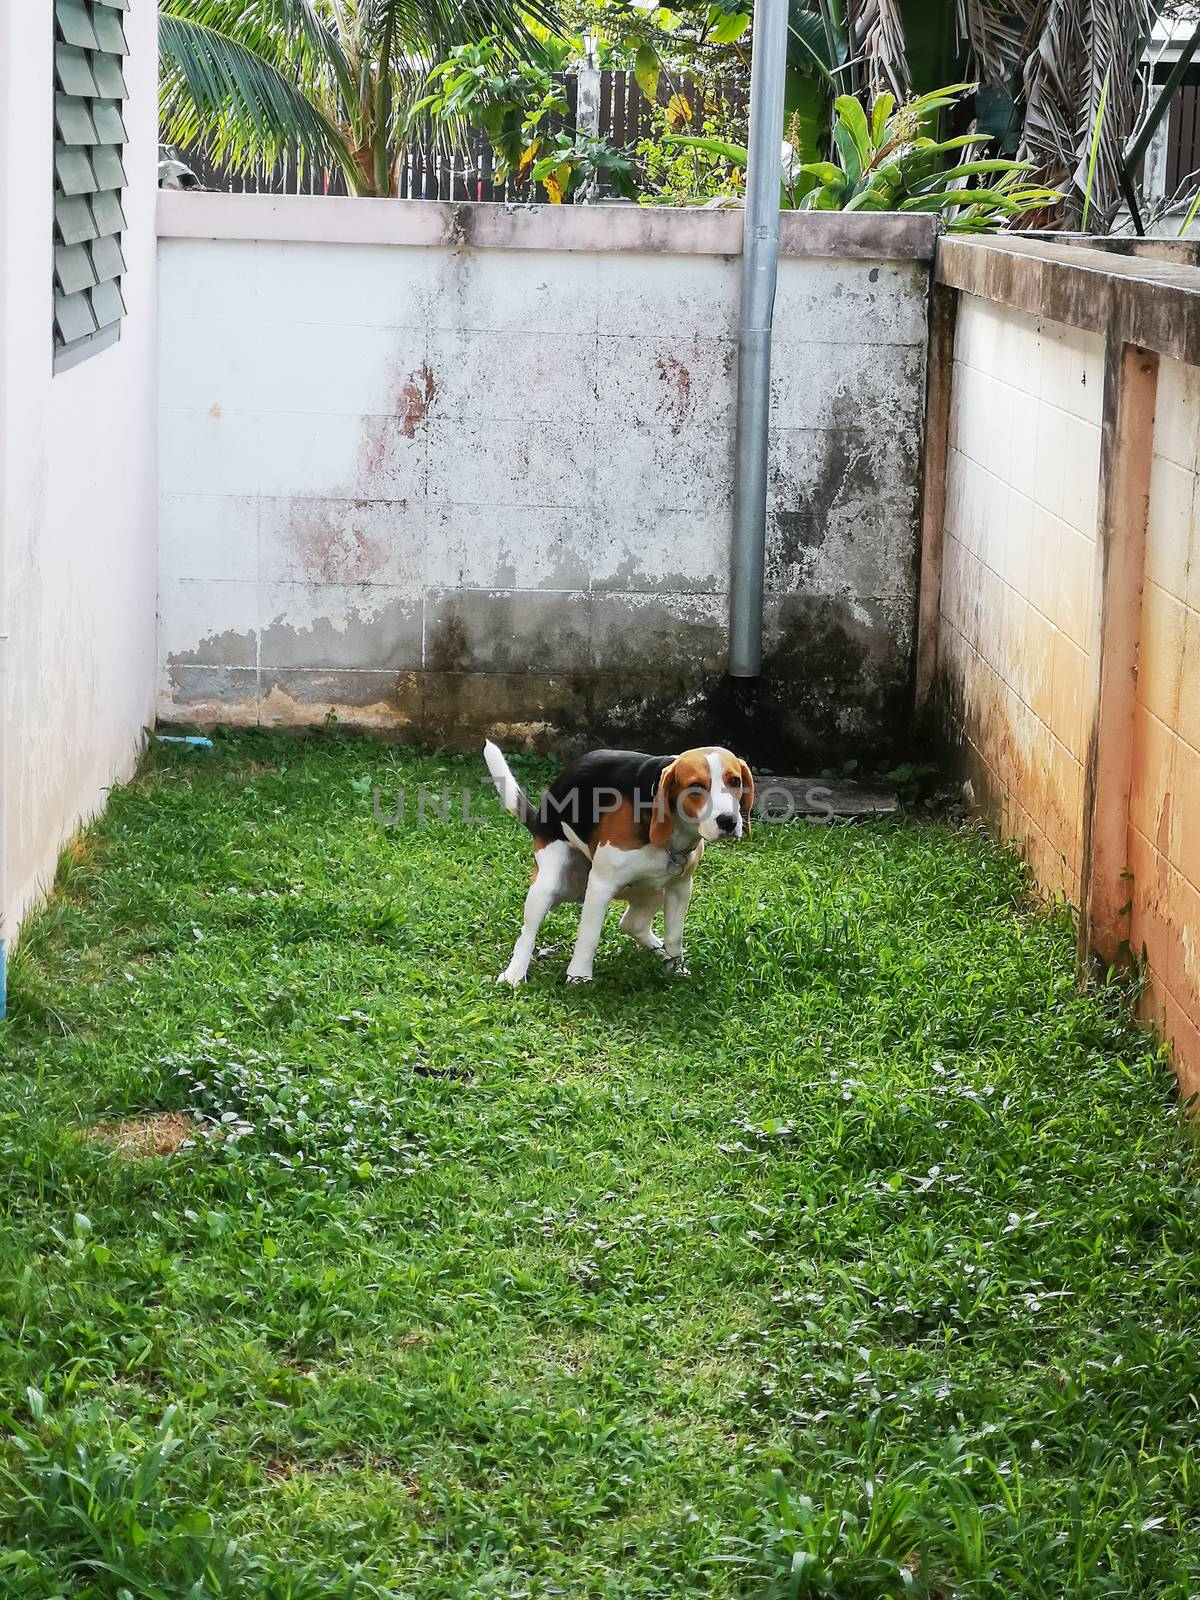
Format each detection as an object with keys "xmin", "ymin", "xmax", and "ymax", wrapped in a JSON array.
[{"xmin": 938, "ymin": 294, "xmax": 1104, "ymax": 901}]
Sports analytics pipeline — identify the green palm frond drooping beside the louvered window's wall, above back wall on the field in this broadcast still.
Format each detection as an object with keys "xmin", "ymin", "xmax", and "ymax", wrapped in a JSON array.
[{"xmin": 158, "ymin": 11, "xmax": 350, "ymax": 180}]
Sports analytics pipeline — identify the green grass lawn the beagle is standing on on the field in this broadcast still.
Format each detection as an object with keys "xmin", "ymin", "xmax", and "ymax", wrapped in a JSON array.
[{"xmin": 0, "ymin": 734, "xmax": 1200, "ymax": 1600}]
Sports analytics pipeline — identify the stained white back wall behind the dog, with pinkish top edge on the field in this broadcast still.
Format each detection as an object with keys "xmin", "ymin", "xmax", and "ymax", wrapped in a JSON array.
[{"xmin": 158, "ymin": 194, "xmax": 933, "ymax": 755}]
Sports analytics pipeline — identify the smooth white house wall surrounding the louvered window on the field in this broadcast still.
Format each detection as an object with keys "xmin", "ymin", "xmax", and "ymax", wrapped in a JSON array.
[{"xmin": 0, "ymin": 0, "xmax": 157, "ymax": 942}]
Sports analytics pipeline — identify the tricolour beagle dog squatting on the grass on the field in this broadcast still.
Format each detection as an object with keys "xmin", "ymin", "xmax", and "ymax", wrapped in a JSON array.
[{"xmin": 483, "ymin": 739, "xmax": 754, "ymax": 987}]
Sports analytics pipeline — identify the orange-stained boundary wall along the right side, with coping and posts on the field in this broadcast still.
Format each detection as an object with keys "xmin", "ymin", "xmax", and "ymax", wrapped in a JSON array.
[{"xmin": 918, "ymin": 238, "xmax": 1200, "ymax": 1093}]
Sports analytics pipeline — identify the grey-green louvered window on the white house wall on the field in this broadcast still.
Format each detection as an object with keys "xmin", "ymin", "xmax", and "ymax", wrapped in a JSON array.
[{"xmin": 54, "ymin": 0, "xmax": 128, "ymax": 368}]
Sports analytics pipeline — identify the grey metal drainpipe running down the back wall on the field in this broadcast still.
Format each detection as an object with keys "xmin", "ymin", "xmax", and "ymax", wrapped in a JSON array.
[{"xmin": 730, "ymin": 0, "xmax": 787, "ymax": 678}]
